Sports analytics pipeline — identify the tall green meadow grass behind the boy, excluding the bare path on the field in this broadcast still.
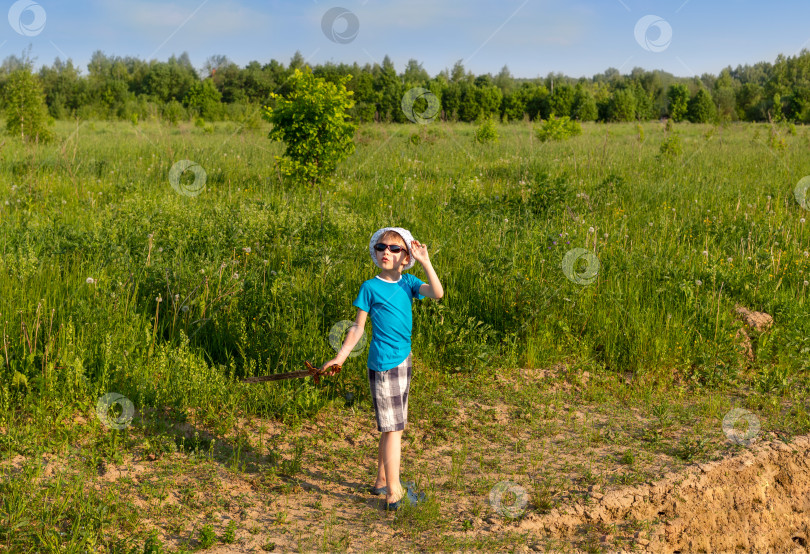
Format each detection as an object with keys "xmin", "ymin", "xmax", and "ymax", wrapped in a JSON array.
[{"xmin": 0, "ymin": 118, "xmax": 810, "ymax": 422}]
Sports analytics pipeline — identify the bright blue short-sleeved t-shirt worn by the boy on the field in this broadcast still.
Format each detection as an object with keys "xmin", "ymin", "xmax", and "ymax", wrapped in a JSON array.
[{"xmin": 352, "ymin": 273, "xmax": 425, "ymax": 371}]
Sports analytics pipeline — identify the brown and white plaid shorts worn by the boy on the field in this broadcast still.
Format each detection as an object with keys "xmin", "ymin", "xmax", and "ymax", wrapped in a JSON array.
[{"xmin": 368, "ymin": 353, "xmax": 412, "ymax": 433}]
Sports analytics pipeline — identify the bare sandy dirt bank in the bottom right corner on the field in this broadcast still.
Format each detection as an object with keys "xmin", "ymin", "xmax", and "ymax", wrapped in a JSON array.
[{"xmin": 519, "ymin": 435, "xmax": 810, "ymax": 553}]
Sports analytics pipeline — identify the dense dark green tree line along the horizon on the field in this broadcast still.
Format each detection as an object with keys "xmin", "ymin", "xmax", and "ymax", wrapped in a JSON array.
[{"xmin": 0, "ymin": 50, "xmax": 810, "ymax": 123}]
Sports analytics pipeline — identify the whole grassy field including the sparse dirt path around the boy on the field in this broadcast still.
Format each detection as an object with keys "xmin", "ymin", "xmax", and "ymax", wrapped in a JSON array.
[{"xmin": 0, "ymin": 118, "xmax": 810, "ymax": 552}]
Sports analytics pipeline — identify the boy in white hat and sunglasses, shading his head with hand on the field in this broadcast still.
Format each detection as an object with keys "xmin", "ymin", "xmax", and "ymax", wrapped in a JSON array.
[{"xmin": 321, "ymin": 227, "xmax": 444, "ymax": 510}]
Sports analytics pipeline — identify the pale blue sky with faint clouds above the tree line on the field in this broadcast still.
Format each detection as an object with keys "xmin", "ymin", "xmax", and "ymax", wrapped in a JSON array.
[{"xmin": 6, "ymin": 0, "xmax": 810, "ymax": 77}]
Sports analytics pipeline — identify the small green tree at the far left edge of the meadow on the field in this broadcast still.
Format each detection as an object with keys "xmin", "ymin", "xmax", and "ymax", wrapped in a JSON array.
[{"xmin": 3, "ymin": 63, "xmax": 53, "ymax": 142}]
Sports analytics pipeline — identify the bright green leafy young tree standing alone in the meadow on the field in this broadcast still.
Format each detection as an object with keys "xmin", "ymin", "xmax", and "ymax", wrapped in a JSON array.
[{"xmin": 262, "ymin": 67, "xmax": 357, "ymax": 189}]
